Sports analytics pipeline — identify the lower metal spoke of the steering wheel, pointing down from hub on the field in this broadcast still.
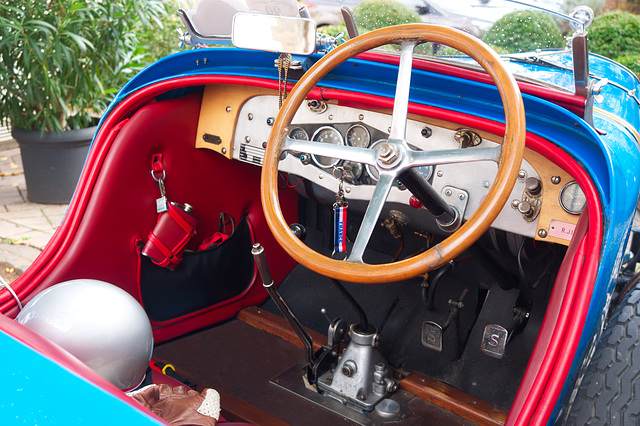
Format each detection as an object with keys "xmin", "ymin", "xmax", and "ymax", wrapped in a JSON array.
[{"xmin": 346, "ymin": 173, "xmax": 397, "ymax": 263}]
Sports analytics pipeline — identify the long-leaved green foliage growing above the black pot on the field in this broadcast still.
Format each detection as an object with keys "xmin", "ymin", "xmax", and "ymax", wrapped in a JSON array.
[{"xmin": 0, "ymin": 0, "xmax": 165, "ymax": 131}]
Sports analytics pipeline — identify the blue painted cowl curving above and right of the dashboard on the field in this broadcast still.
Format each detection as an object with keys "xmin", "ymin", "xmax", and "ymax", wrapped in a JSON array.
[{"xmin": 61, "ymin": 42, "xmax": 640, "ymax": 423}]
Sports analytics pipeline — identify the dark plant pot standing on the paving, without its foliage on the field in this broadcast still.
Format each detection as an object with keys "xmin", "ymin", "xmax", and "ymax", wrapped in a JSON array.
[{"xmin": 11, "ymin": 127, "xmax": 97, "ymax": 204}]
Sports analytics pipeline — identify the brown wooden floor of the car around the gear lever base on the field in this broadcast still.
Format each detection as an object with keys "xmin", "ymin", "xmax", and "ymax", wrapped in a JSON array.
[{"xmin": 154, "ymin": 307, "xmax": 506, "ymax": 426}]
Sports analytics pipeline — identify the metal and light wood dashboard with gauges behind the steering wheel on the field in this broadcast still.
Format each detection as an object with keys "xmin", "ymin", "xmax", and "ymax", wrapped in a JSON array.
[{"xmin": 196, "ymin": 86, "xmax": 585, "ymax": 245}]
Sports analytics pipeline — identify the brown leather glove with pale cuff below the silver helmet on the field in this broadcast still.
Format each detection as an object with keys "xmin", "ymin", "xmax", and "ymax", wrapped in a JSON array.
[{"xmin": 129, "ymin": 385, "xmax": 220, "ymax": 426}]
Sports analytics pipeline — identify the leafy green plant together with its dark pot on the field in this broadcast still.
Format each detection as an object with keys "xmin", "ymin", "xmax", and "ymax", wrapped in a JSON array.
[{"xmin": 0, "ymin": 0, "xmax": 166, "ymax": 203}]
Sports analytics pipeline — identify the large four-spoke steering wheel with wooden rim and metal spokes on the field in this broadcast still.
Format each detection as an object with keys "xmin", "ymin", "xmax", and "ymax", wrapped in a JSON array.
[{"xmin": 260, "ymin": 24, "xmax": 526, "ymax": 283}]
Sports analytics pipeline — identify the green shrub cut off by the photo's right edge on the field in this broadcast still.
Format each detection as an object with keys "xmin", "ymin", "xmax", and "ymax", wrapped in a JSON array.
[{"xmin": 589, "ymin": 12, "xmax": 640, "ymax": 62}]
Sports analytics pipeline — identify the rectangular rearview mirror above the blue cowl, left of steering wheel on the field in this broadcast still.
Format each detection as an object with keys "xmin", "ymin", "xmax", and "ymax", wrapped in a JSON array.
[{"xmin": 231, "ymin": 13, "xmax": 316, "ymax": 55}]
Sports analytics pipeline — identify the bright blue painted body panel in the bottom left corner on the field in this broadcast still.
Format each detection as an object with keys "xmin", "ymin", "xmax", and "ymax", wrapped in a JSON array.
[{"xmin": 0, "ymin": 333, "xmax": 164, "ymax": 426}]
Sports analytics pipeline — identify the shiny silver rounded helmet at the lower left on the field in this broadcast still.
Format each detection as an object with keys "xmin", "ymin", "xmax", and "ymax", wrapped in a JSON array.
[{"xmin": 16, "ymin": 279, "xmax": 153, "ymax": 390}]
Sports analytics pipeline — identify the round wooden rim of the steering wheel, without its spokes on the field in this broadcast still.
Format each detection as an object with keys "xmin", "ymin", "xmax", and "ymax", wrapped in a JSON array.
[{"xmin": 260, "ymin": 24, "xmax": 526, "ymax": 283}]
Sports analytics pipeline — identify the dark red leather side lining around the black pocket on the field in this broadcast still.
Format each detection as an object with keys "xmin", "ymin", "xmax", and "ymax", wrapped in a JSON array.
[{"xmin": 18, "ymin": 89, "xmax": 297, "ymax": 342}]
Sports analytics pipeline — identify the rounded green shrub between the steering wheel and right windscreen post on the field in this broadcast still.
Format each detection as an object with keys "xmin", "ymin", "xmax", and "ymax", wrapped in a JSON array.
[{"xmin": 484, "ymin": 10, "xmax": 565, "ymax": 53}]
